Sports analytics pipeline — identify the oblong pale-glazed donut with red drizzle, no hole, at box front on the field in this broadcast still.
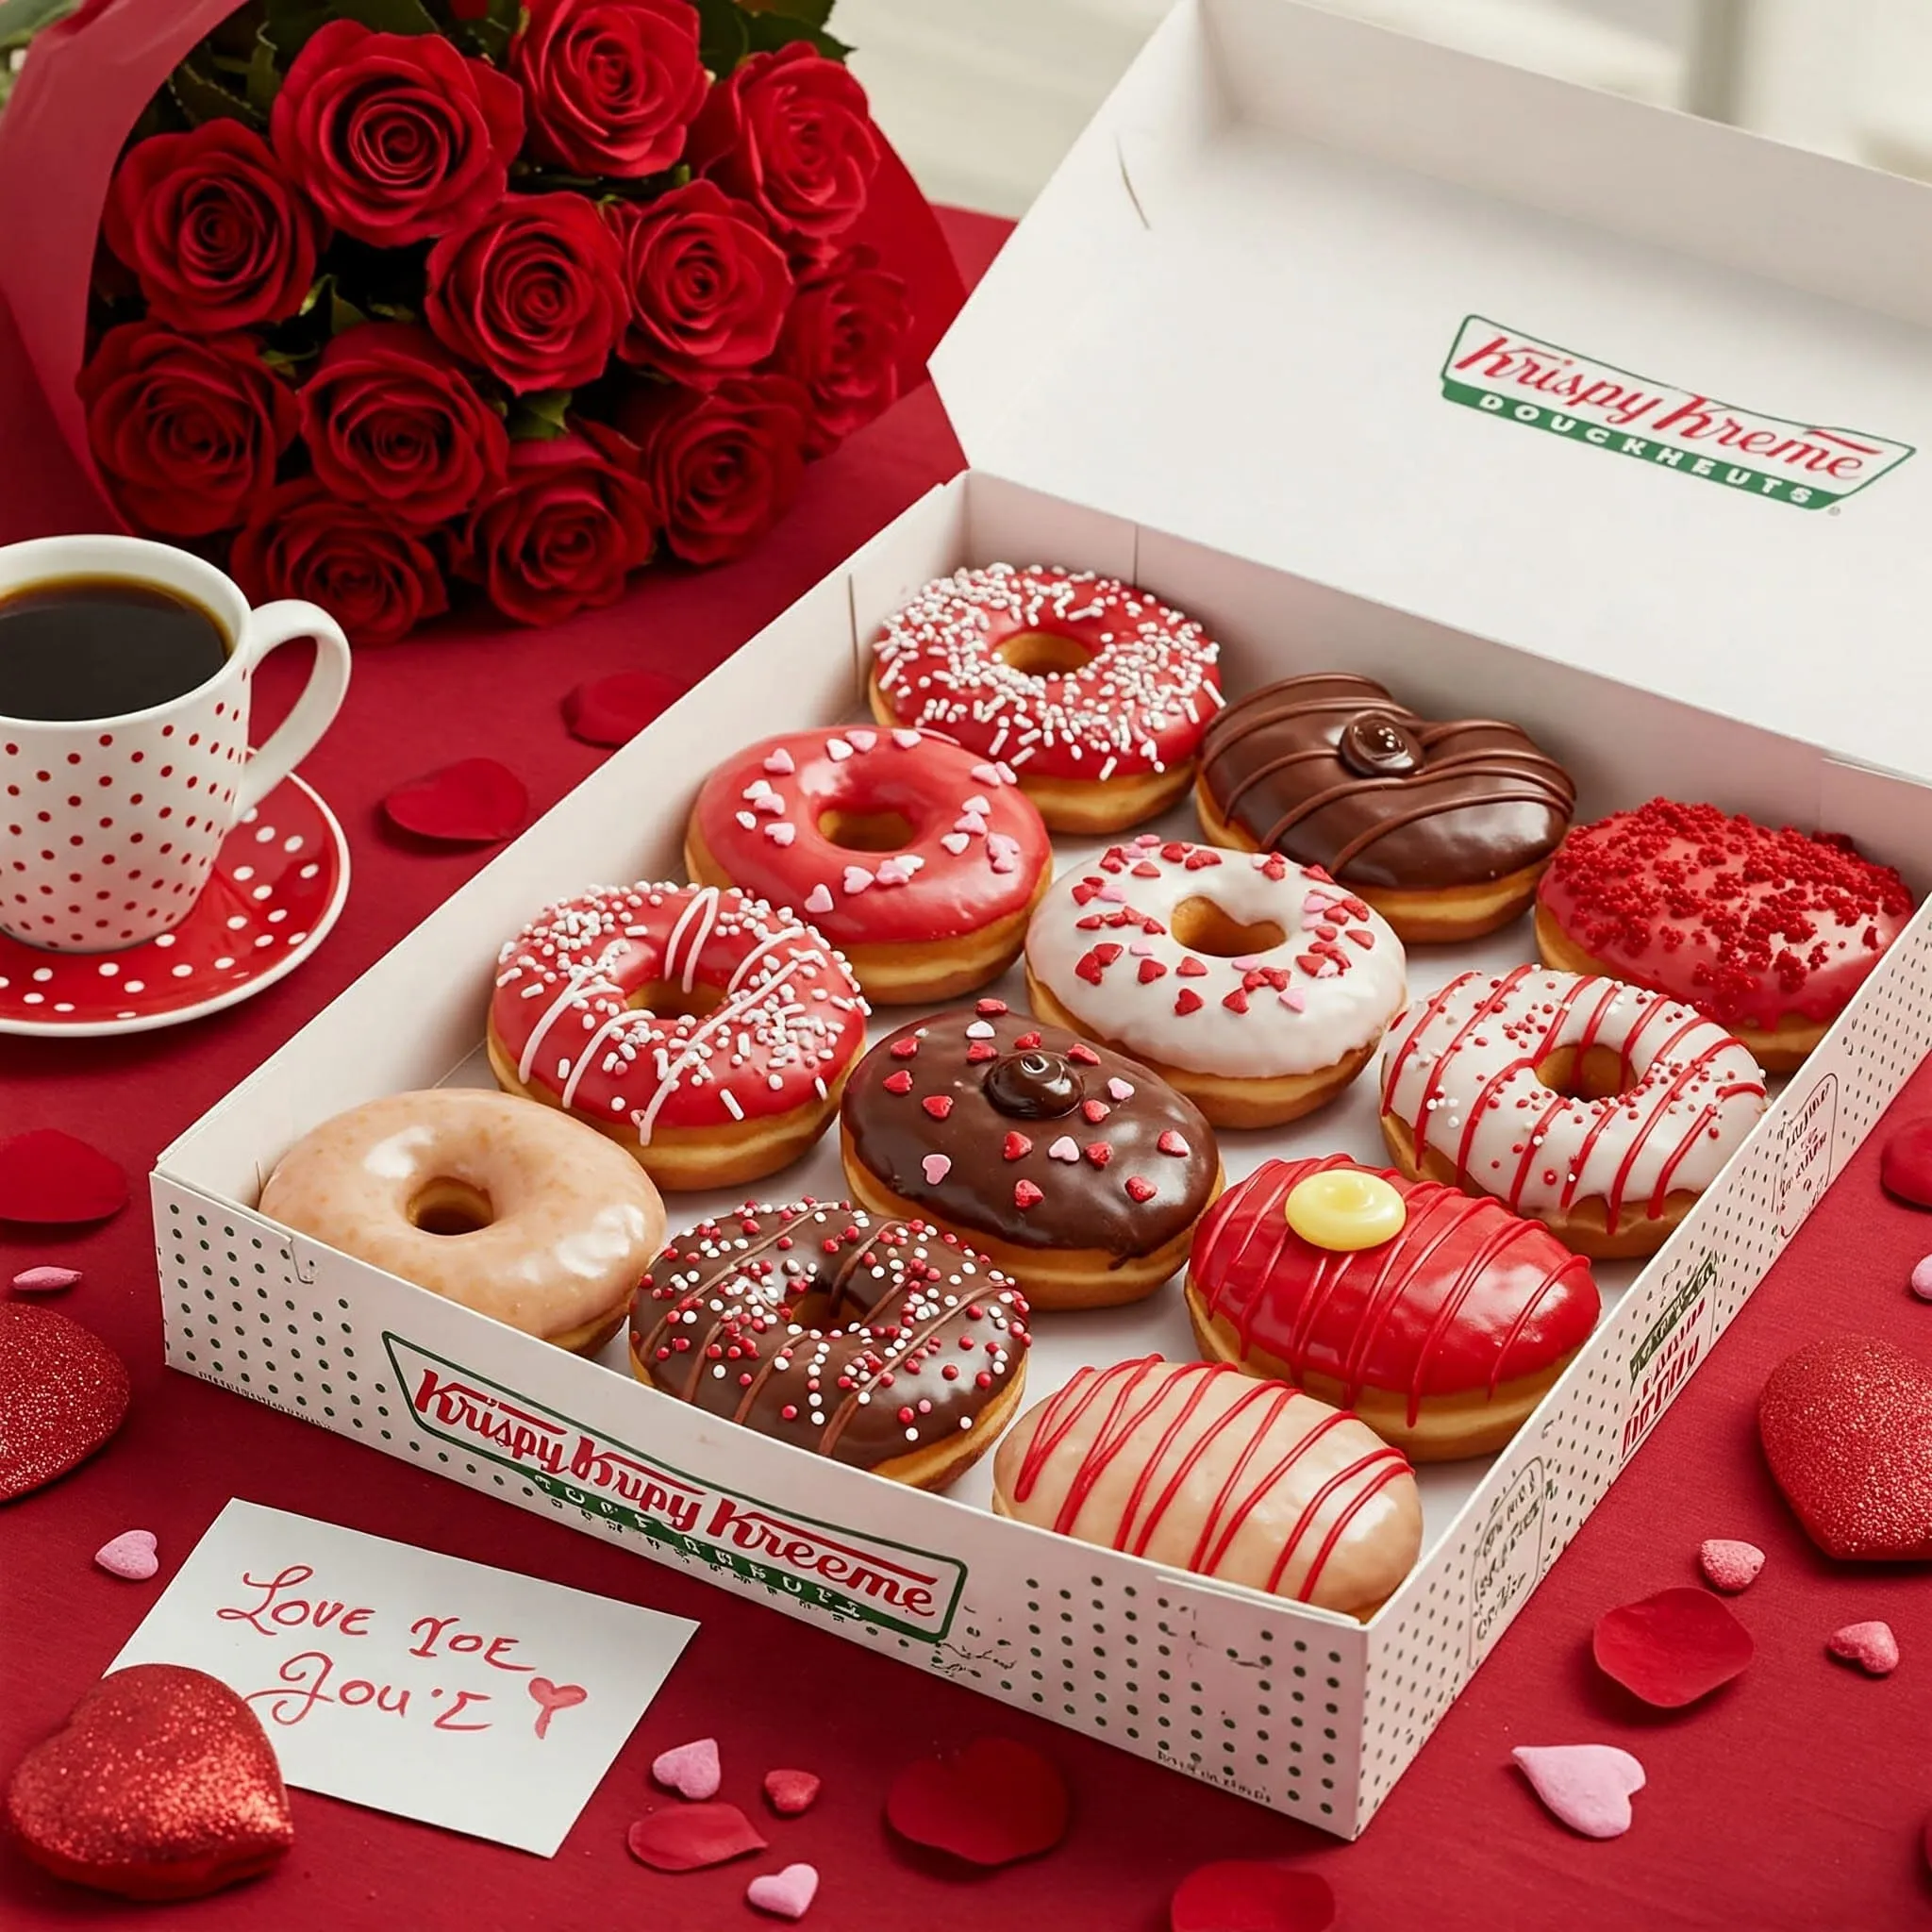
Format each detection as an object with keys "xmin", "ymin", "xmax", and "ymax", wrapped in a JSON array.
[{"xmin": 993, "ymin": 1357, "xmax": 1422, "ymax": 1617}]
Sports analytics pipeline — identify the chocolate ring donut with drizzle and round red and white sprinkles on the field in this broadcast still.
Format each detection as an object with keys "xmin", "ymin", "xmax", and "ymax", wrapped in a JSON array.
[{"xmin": 630, "ymin": 1200, "xmax": 1028, "ymax": 1490}]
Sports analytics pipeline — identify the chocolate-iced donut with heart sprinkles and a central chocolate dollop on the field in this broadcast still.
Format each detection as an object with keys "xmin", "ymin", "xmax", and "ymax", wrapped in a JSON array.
[{"xmin": 841, "ymin": 999, "xmax": 1221, "ymax": 1307}]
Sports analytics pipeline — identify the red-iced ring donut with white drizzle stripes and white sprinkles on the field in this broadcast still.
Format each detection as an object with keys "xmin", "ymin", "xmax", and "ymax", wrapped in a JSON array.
[{"xmin": 489, "ymin": 885, "xmax": 868, "ymax": 1189}]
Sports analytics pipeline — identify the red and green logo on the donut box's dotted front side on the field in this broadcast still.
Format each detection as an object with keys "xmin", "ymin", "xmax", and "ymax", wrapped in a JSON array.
[{"xmin": 383, "ymin": 1333, "xmax": 966, "ymax": 1641}]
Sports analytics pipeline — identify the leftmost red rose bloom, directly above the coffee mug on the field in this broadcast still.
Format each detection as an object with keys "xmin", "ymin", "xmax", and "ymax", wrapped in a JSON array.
[{"xmin": 77, "ymin": 323, "xmax": 299, "ymax": 537}]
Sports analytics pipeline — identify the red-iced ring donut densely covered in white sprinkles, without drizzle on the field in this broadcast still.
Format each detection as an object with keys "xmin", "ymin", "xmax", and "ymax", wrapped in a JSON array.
[{"xmin": 872, "ymin": 564, "xmax": 1221, "ymax": 833}]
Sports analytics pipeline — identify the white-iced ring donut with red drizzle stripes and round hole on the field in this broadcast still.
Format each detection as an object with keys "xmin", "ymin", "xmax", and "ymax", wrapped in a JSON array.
[{"xmin": 1381, "ymin": 966, "xmax": 1764, "ymax": 1259}]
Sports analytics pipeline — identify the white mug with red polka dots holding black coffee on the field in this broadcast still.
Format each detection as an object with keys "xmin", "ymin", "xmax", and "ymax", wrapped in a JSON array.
[{"xmin": 0, "ymin": 537, "xmax": 350, "ymax": 953}]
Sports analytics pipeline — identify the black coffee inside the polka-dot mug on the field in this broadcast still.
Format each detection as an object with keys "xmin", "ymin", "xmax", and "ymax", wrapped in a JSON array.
[{"xmin": 0, "ymin": 577, "xmax": 228, "ymax": 721}]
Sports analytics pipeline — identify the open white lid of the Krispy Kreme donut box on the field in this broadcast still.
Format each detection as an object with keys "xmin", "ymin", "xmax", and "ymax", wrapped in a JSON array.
[{"xmin": 933, "ymin": 0, "xmax": 1932, "ymax": 791}]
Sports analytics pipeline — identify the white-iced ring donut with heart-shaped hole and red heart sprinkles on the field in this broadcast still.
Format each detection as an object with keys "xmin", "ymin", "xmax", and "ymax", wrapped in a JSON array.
[{"xmin": 1025, "ymin": 833, "xmax": 1408, "ymax": 1126}]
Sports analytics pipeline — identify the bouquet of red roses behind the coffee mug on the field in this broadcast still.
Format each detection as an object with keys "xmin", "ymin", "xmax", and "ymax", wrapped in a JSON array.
[{"xmin": 0, "ymin": 0, "xmax": 961, "ymax": 643}]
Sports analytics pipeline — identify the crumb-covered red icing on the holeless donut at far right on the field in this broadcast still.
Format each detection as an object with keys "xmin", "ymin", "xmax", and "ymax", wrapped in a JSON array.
[{"xmin": 1538, "ymin": 798, "xmax": 1913, "ymax": 1028}]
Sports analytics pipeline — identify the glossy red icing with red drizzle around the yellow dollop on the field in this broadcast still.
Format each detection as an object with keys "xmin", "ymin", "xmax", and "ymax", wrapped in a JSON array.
[{"xmin": 1189, "ymin": 1154, "xmax": 1600, "ymax": 1425}]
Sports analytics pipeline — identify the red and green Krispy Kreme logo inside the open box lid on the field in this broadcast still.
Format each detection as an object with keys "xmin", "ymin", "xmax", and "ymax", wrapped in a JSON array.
[{"xmin": 1443, "ymin": 315, "xmax": 1913, "ymax": 510}]
